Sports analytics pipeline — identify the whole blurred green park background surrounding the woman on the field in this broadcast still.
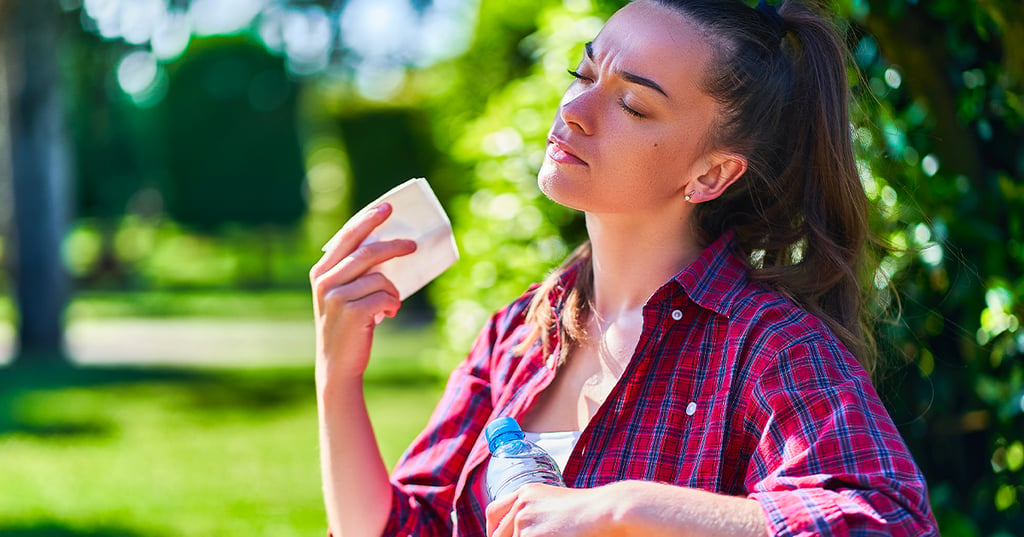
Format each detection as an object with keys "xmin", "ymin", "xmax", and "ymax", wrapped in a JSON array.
[{"xmin": 0, "ymin": 0, "xmax": 1024, "ymax": 537}]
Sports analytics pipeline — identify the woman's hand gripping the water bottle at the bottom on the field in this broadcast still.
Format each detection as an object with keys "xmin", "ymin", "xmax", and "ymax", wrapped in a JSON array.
[{"xmin": 487, "ymin": 484, "xmax": 614, "ymax": 537}]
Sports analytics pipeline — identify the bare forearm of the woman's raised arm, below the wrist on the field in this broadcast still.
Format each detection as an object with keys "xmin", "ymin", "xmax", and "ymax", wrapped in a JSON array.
[{"xmin": 317, "ymin": 377, "xmax": 391, "ymax": 537}]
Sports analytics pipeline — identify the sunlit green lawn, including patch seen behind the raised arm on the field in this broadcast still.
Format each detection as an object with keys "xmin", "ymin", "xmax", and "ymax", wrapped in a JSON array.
[{"xmin": 0, "ymin": 332, "xmax": 441, "ymax": 537}]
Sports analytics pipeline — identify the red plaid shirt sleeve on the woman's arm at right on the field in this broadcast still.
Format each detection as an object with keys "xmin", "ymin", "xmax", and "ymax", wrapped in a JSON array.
[{"xmin": 745, "ymin": 339, "xmax": 938, "ymax": 537}]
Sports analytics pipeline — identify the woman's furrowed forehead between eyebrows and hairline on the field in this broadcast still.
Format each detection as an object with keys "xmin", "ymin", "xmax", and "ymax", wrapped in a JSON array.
[{"xmin": 593, "ymin": 0, "xmax": 710, "ymax": 94}]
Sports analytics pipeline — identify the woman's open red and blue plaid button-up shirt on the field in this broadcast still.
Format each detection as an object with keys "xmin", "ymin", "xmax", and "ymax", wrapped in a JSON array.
[{"xmin": 374, "ymin": 234, "xmax": 937, "ymax": 537}]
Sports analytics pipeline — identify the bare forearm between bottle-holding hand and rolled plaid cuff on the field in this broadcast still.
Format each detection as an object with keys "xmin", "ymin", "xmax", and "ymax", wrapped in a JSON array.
[{"xmin": 609, "ymin": 481, "xmax": 768, "ymax": 537}]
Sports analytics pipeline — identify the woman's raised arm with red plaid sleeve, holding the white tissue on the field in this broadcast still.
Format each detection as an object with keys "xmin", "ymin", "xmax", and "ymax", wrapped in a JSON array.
[{"xmin": 311, "ymin": 211, "xmax": 520, "ymax": 537}]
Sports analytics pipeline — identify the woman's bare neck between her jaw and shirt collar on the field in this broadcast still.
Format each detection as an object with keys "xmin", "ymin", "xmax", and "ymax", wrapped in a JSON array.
[{"xmin": 587, "ymin": 210, "xmax": 701, "ymax": 320}]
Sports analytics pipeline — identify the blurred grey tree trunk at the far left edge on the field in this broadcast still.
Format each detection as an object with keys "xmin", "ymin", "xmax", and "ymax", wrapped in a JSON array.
[{"xmin": 0, "ymin": 0, "xmax": 71, "ymax": 365}]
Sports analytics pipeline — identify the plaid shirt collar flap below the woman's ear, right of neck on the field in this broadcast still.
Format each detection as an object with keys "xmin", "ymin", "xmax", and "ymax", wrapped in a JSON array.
[{"xmin": 673, "ymin": 231, "xmax": 749, "ymax": 317}]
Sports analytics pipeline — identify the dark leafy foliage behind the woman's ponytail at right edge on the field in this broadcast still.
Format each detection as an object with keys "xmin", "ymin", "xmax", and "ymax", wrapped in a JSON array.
[{"xmin": 844, "ymin": 0, "xmax": 1024, "ymax": 536}]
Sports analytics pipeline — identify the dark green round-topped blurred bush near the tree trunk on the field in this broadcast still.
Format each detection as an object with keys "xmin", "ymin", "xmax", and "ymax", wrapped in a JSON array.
[{"xmin": 157, "ymin": 38, "xmax": 305, "ymax": 230}]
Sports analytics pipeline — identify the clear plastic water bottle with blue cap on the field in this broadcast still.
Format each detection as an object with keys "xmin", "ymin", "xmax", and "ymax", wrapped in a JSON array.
[{"xmin": 483, "ymin": 417, "xmax": 565, "ymax": 501}]
